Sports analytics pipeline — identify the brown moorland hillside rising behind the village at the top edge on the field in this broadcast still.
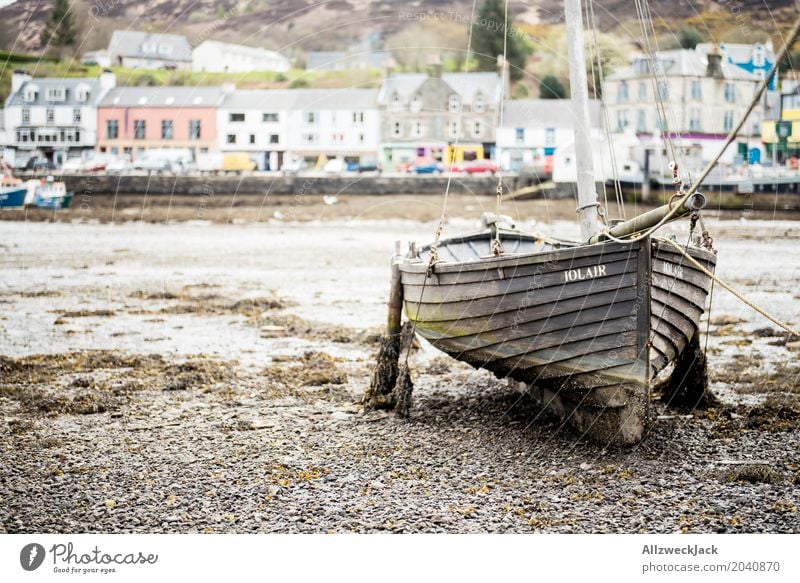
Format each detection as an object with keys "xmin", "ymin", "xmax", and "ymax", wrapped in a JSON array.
[{"xmin": 0, "ymin": 0, "xmax": 794, "ymax": 54}]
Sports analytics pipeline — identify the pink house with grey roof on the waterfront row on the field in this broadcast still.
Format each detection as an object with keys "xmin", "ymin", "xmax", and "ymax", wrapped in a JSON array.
[{"xmin": 97, "ymin": 87, "xmax": 228, "ymax": 160}]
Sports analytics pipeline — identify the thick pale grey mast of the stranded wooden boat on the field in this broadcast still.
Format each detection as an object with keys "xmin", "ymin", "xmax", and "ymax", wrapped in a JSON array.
[{"xmin": 564, "ymin": 0, "xmax": 600, "ymax": 241}]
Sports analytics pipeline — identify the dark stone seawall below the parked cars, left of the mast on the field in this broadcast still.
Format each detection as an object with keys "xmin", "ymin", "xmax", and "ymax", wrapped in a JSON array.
[{"xmin": 63, "ymin": 174, "xmax": 556, "ymax": 196}]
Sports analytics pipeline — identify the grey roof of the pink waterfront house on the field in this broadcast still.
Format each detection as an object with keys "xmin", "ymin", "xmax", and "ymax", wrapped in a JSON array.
[{"xmin": 98, "ymin": 87, "xmax": 225, "ymax": 107}]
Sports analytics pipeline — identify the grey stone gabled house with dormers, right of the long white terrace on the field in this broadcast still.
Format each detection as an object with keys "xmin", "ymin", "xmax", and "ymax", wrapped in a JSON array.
[{"xmin": 378, "ymin": 63, "xmax": 508, "ymax": 168}]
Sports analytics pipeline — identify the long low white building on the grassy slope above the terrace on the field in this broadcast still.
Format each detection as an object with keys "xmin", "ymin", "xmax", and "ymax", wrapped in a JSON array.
[{"xmin": 192, "ymin": 40, "xmax": 292, "ymax": 73}]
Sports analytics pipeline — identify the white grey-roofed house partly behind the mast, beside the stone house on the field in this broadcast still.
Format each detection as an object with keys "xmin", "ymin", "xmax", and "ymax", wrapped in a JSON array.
[{"xmin": 497, "ymin": 99, "xmax": 601, "ymax": 172}]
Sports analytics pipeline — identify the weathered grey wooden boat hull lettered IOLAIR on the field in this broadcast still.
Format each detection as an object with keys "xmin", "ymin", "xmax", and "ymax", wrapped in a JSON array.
[{"xmin": 400, "ymin": 230, "xmax": 714, "ymax": 443}]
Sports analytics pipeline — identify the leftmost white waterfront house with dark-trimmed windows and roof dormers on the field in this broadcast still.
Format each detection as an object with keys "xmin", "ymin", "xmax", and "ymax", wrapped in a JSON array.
[{"xmin": 4, "ymin": 72, "xmax": 116, "ymax": 164}]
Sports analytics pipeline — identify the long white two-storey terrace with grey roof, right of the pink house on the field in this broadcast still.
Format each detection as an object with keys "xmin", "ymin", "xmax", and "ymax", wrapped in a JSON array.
[{"xmin": 217, "ymin": 89, "xmax": 380, "ymax": 170}]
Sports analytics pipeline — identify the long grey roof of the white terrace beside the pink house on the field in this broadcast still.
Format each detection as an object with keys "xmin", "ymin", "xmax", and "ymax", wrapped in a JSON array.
[{"xmin": 222, "ymin": 89, "xmax": 378, "ymax": 111}]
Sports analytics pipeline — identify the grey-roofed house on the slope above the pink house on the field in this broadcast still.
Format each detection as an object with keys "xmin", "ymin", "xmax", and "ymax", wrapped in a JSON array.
[{"xmin": 104, "ymin": 30, "xmax": 192, "ymax": 70}]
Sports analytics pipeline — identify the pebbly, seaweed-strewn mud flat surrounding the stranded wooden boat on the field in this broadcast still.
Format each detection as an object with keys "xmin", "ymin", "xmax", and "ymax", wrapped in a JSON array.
[{"xmin": 0, "ymin": 210, "xmax": 800, "ymax": 532}]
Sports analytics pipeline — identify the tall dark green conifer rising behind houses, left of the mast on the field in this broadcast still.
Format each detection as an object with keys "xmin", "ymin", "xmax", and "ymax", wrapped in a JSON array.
[{"xmin": 472, "ymin": 0, "xmax": 528, "ymax": 81}]
